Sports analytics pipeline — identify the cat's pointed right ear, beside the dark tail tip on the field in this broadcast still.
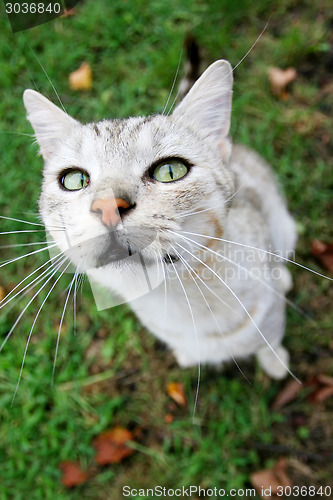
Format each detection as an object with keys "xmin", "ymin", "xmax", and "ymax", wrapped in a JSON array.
[{"xmin": 172, "ymin": 60, "xmax": 233, "ymax": 144}]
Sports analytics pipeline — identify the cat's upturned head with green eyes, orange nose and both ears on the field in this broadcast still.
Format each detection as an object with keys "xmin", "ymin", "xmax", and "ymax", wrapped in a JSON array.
[{"xmin": 24, "ymin": 61, "xmax": 234, "ymax": 278}]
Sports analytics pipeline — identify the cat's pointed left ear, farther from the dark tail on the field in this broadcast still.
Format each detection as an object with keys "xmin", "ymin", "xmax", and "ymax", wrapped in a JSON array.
[{"xmin": 23, "ymin": 89, "xmax": 80, "ymax": 160}]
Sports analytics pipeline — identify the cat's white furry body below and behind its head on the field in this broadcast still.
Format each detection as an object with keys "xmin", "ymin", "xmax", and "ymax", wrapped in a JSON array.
[{"xmin": 124, "ymin": 146, "xmax": 295, "ymax": 377}]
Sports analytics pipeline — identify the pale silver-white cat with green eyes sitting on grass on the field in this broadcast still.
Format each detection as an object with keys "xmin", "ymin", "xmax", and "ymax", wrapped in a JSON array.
[{"xmin": 24, "ymin": 60, "xmax": 297, "ymax": 379}]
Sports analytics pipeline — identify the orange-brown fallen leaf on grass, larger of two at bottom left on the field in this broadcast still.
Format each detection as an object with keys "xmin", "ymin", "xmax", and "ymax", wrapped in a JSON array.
[{"xmin": 93, "ymin": 426, "xmax": 135, "ymax": 465}]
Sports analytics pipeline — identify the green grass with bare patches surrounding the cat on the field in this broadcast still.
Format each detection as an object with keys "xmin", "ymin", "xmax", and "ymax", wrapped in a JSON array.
[{"xmin": 0, "ymin": 0, "xmax": 333, "ymax": 500}]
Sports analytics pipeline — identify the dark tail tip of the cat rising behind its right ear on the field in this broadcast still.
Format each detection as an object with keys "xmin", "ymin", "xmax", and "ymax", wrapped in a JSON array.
[{"xmin": 178, "ymin": 35, "xmax": 202, "ymax": 101}]
